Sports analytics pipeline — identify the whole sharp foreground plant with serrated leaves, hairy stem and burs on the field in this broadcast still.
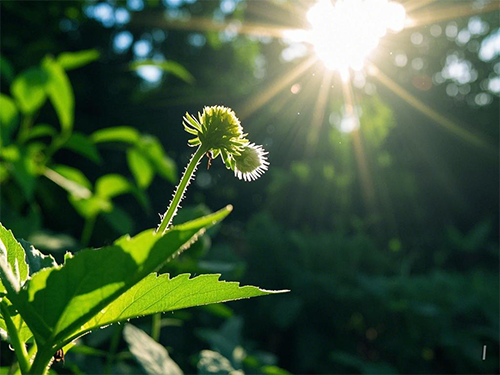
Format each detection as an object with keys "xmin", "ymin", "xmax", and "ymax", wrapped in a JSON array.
[{"xmin": 0, "ymin": 99, "xmax": 282, "ymax": 375}]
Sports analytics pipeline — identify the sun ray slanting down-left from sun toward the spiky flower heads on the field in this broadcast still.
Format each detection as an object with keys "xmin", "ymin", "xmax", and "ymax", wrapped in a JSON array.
[{"xmin": 240, "ymin": 55, "xmax": 317, "ymax": 119}]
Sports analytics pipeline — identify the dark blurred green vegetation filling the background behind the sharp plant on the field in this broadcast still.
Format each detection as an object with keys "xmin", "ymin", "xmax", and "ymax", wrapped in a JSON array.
[{"xmin": 0, "ymin": 0, "xmax": 500, "ymax": 375}]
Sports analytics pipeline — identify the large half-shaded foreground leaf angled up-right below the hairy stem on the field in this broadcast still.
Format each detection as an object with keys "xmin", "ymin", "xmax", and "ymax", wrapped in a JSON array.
[{"xmin": 16, "ymin": 207, "xmax": 230, "ymax": 345}]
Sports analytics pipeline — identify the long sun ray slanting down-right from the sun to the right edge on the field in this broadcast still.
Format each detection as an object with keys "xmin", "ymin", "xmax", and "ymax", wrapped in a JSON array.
[{"xmin": 368, "ymin": 63, "xmax": 500, "ymax": 156}]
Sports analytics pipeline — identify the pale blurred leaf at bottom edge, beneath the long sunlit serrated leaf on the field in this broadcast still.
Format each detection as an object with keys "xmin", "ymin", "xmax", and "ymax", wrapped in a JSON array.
[{"xmin": 123, "ymin": 324, "xmax": 183, "ymax": 375}]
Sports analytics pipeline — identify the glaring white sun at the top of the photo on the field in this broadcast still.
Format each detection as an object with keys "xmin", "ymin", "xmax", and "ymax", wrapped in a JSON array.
[{"xmin": 307, "ymin": 0, "xmax": 406, "ymax": 77}]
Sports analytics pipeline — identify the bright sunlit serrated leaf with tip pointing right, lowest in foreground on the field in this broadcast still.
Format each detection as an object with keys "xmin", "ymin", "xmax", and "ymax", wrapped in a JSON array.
[{"xmin": 85, "ymin": 273, "xmax": 284, "ymax": 331}]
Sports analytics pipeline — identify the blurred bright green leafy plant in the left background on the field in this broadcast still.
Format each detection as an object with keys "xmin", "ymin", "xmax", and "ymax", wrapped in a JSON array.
[{"xmin": 0, "ymin": 50, "xmax": 177, "ymax": 246}]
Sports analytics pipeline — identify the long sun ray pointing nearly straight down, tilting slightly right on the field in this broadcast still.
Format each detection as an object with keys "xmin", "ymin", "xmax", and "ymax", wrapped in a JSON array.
[{"xmin": 342, "ymin": 80, "xmax": 375, "ymax": 212}]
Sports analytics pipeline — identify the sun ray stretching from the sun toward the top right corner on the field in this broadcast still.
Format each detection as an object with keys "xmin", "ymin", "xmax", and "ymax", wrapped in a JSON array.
[{"xmin": 405, "ymin": 1, "xmax": 500, "ymax": 29}]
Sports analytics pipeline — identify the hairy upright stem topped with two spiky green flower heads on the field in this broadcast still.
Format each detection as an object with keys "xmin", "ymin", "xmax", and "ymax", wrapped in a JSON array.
[{"xmin": 157, "ymin": 105, "xmax": 269, "ymax": 233}]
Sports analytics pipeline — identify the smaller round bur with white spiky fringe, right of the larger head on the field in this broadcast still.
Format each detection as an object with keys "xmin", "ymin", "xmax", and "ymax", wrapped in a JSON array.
[{"xmin": 234, "ymin": 143, "xmax": 269, "ymax": 181}]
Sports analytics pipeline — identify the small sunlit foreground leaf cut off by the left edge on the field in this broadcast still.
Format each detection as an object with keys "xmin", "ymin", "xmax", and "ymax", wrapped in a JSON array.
[{"xmin": 0, "ymin": 223, "xmax": 28, "ymax": 293}]
